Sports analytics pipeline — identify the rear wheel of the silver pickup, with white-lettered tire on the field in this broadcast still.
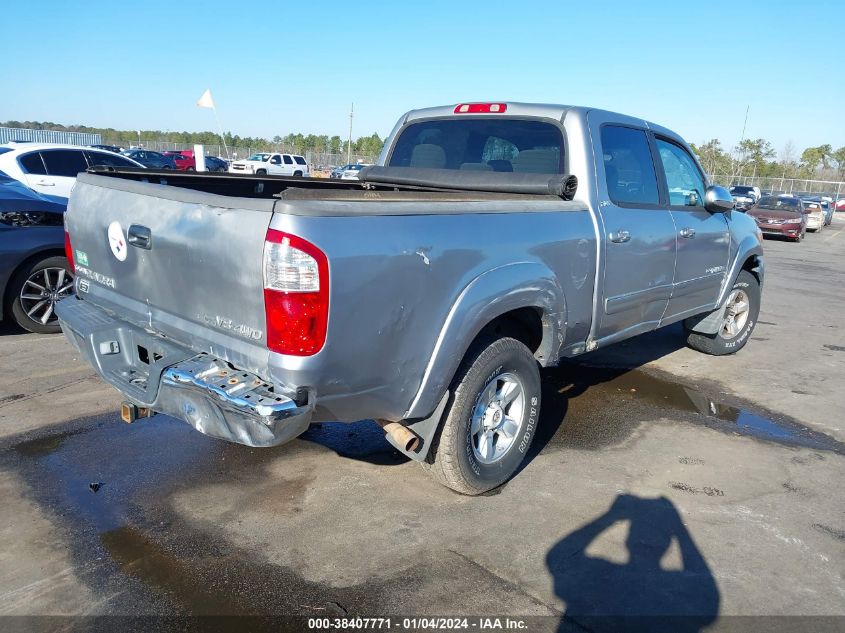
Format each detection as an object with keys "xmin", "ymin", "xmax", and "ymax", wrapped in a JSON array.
[{"xmin": 424, "ymin": 338, "xmax": 540, "ymax": 495}]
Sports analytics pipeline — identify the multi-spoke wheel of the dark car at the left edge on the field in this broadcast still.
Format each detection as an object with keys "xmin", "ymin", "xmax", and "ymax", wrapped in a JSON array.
[{"xmin": 6, "ymin": 256, "xmax": 73, "ymax": 334}]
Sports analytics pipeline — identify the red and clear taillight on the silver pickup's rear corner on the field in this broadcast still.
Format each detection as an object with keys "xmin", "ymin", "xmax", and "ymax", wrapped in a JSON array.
[{"xmin": 264, "ymin": 229, "xmax": 329, "ymax": 356}]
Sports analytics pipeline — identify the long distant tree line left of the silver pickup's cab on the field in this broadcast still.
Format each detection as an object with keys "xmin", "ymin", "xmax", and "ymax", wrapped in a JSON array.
[{"xmin": 0, "ymin": 121, "xmax": 384, "ymax": 157}]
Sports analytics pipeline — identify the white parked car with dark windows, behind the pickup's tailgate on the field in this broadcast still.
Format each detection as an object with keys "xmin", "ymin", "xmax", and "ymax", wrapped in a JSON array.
[{"xmin": 0, "ymin": 143, "xmax": 143, "ymax": 198}]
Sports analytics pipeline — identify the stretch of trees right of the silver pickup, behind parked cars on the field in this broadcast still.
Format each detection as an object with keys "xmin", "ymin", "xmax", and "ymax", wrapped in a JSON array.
[{"xmin": 692, "ymin": 138, "xmax": 845, "ymax": 180}]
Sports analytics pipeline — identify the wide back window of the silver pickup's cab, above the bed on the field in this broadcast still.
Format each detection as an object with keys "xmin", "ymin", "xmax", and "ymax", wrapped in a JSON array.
[{"xmin": 388, "ymin": 117, "xmax": 564, "ymax": 174}]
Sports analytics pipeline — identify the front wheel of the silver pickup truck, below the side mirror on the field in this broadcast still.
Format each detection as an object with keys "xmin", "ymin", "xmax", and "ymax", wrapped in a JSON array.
[{"xmin": 687, "ymin": 270, "xmax": 761, "ymax": 356}]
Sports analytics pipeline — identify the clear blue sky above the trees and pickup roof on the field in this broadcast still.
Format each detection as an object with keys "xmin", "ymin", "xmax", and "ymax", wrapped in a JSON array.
[{"xmin": 0, "ymin": 0, "xmax": 845, "ymax": 152}]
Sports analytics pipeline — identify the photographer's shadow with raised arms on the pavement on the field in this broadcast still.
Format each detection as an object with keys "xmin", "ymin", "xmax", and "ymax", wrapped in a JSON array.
[{"xmin": 546, "ymin": 495, "xmax": 719, "ymax": 633}]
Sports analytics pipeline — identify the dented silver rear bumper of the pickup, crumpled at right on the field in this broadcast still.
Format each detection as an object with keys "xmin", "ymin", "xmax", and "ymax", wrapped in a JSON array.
[{"xmin": 56, "ymin": 297, "xmax": 314, "ymax": 447}]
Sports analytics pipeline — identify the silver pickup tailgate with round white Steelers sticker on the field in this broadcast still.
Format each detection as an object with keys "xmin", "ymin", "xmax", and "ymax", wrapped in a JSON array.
[{"xmin": 66, "ymin": 174, "xmax": 275, "ymax": 350}]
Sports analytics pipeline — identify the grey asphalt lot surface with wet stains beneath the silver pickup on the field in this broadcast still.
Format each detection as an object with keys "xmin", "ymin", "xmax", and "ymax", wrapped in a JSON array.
[{"xmin": 0, "ymin": 214, "xmax": 845, "ymax": 631}]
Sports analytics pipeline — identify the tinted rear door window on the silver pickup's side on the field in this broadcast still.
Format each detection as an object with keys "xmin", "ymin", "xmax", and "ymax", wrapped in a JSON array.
[{"xmin": 601, "ymin": 125, "xmax": 660, "ymax": 205}]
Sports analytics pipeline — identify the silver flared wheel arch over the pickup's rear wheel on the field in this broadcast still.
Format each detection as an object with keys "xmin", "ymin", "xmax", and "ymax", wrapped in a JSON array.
[{"xmin": 404, "ymin": 262, "xmax": 566, "ymax": 419}]
